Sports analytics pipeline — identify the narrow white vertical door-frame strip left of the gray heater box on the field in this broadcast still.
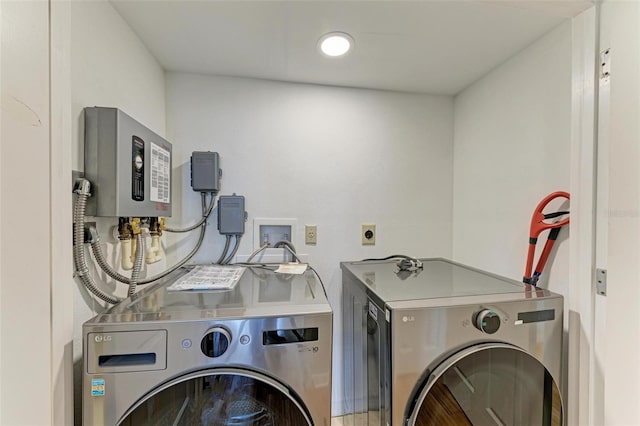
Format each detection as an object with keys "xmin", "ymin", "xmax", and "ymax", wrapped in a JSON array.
[{"xmin": 49, "ymin": 0, "xmax": 76, "ymax": 425}]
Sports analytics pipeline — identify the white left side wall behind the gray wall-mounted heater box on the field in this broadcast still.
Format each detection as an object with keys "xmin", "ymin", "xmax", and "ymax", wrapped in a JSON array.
[{"xmin": 69, "ymin": 0, "xmax": 165, "ymax": 422}]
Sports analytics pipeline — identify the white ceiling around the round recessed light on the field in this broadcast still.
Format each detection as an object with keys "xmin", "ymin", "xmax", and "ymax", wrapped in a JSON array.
[{"xmin": 111, "ymin": 0, "xmax": 592, "ymax": 94}]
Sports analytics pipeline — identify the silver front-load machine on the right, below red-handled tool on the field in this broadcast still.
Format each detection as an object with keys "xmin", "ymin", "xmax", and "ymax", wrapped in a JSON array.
[{"xmin": 341, "ymin": 259, "xmax": 564, "ymax": 426}]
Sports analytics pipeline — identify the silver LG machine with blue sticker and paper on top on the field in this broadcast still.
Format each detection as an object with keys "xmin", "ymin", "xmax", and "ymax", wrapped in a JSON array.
[{"xmin": 83, "ymin": 267, "xmax": 333, "ymax": 426}]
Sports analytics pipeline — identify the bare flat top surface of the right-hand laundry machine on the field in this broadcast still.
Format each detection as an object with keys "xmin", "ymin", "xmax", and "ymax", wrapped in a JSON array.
[{"xmin": 341, "ymin": 259, "xmax": 552, "ymax": 306}]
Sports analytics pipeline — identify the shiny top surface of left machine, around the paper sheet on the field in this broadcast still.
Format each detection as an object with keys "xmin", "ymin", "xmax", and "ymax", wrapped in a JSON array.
[{"xmin": 87, "ymin": 267, "xmax": 331, "ymax": 325}]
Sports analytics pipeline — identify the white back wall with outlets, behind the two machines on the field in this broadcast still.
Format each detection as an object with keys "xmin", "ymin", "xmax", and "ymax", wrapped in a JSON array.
[{"xmin": 167, "ymin": 74, "xmax": 453, "ymax": 414}]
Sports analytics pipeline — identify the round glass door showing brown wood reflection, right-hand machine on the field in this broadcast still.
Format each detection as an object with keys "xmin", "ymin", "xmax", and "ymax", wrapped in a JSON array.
[{"xmin": 407, "ymin": 343, "xmax": 563, "ymax": 426}]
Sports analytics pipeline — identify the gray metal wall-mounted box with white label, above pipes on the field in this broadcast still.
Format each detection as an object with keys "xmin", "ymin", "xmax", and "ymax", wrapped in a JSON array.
[{"xmin": 84, "ymin": 107, "xmax": 172, "ymax": 217}]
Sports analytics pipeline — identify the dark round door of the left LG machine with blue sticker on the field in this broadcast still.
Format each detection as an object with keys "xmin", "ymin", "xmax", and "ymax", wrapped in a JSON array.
[{"xmin": 118, "ymin": 368, "xmax": 312, "ymax": 426}]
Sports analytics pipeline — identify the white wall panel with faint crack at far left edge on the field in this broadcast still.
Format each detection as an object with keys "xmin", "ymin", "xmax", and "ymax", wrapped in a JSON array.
[{"xmin": 0, "ymin": 1, "xmax": 54, "ymax": 425}]
